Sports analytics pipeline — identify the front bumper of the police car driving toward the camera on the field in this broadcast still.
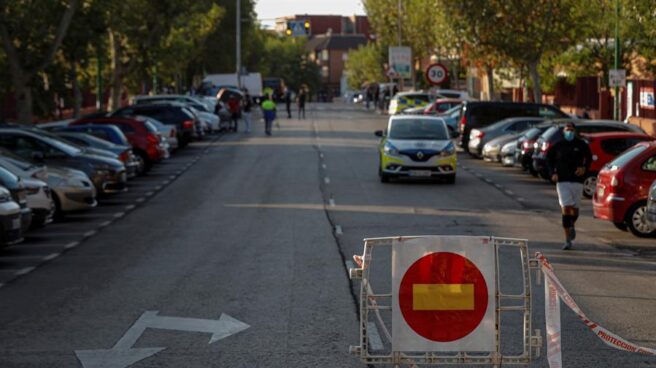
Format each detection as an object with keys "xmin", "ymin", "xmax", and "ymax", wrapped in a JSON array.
[{"xmin": 381, "ymin": 154, "xmax": 457, "ymax": 177}]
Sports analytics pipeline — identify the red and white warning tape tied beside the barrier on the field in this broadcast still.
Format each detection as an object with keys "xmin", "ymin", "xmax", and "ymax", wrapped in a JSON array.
[{"xmin": 535, "ymin": 252, "xmax": 656, "ymax": 368}]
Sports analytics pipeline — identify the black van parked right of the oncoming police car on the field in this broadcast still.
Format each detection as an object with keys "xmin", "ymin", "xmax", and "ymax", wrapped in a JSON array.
[{"xmin": 458, "ymin": 101, "xmax": 568, "ymax": 152}]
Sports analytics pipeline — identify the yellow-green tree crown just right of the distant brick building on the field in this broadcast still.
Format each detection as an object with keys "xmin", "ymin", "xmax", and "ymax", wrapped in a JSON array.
[{"xmin": 346, "ymin": 43, "xmax": 386, "ymax": 90}]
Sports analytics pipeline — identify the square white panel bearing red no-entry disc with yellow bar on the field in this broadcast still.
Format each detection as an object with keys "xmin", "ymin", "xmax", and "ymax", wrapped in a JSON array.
[{"xmin": 392, "ymin": 236, "xmax": 496, "ymax": 352}]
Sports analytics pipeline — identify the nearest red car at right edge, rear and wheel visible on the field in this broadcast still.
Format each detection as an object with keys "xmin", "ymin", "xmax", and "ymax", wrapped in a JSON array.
[{"xmin": 592, "ymin": 141, "xmax": 656, "ymax": 237}]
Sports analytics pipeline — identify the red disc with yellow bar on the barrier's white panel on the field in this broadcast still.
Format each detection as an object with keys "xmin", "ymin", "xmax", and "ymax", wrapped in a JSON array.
[{"xmin": 399, "ymin": 252, "xmax": 488, "ymax": 342}]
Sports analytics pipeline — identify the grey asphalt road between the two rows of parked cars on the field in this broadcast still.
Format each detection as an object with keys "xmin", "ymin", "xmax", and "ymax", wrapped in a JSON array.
[{"xmin": 0, "ymin": 104, "xmax": 656, "ymax": 368}]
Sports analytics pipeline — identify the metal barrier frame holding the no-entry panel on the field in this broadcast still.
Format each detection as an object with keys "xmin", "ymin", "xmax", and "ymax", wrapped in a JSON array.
[{"xmin": 349, "ymin": 237, "xmax": 542, "ymax": 366}]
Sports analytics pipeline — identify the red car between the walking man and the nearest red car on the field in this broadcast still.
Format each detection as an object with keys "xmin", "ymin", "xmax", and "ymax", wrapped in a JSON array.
[{"xmin": 582, "ymin": 132, "xmax": 654, "ymax": 198}]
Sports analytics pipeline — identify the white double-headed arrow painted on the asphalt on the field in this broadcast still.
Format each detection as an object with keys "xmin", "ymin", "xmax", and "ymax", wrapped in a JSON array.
[{"xmin": 75, "ymin": 311, "xmax": 250, "ymax": 368}]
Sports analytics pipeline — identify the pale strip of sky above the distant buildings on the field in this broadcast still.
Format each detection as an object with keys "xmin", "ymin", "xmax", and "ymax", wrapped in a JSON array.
[{"xmin": 255, "ymin": 0, "xmax": 364, "ymax": 26}]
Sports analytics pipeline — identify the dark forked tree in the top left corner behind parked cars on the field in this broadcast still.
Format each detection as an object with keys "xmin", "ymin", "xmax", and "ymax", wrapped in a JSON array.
[{"xmin": 0, "ymin": 0, "xmax": 79, "ymax": 124}]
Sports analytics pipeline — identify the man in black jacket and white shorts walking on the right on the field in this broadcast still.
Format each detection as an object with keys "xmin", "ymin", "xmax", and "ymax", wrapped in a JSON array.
[{"xmin": 547, "ymin": 122, "xmax": 592, "ymax": 250}]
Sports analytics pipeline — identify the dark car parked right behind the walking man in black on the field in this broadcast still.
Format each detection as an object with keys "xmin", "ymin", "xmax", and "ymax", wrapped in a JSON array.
[{"xmin": 532, "ymin": 119, "xmax": 645, "ymax": 180}]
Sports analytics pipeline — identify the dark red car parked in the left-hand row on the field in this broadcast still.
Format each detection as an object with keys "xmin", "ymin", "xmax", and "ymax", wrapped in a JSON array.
[{"xmin": 70, "ymin": 117, "xmax": 168, "ymax": 169}]
